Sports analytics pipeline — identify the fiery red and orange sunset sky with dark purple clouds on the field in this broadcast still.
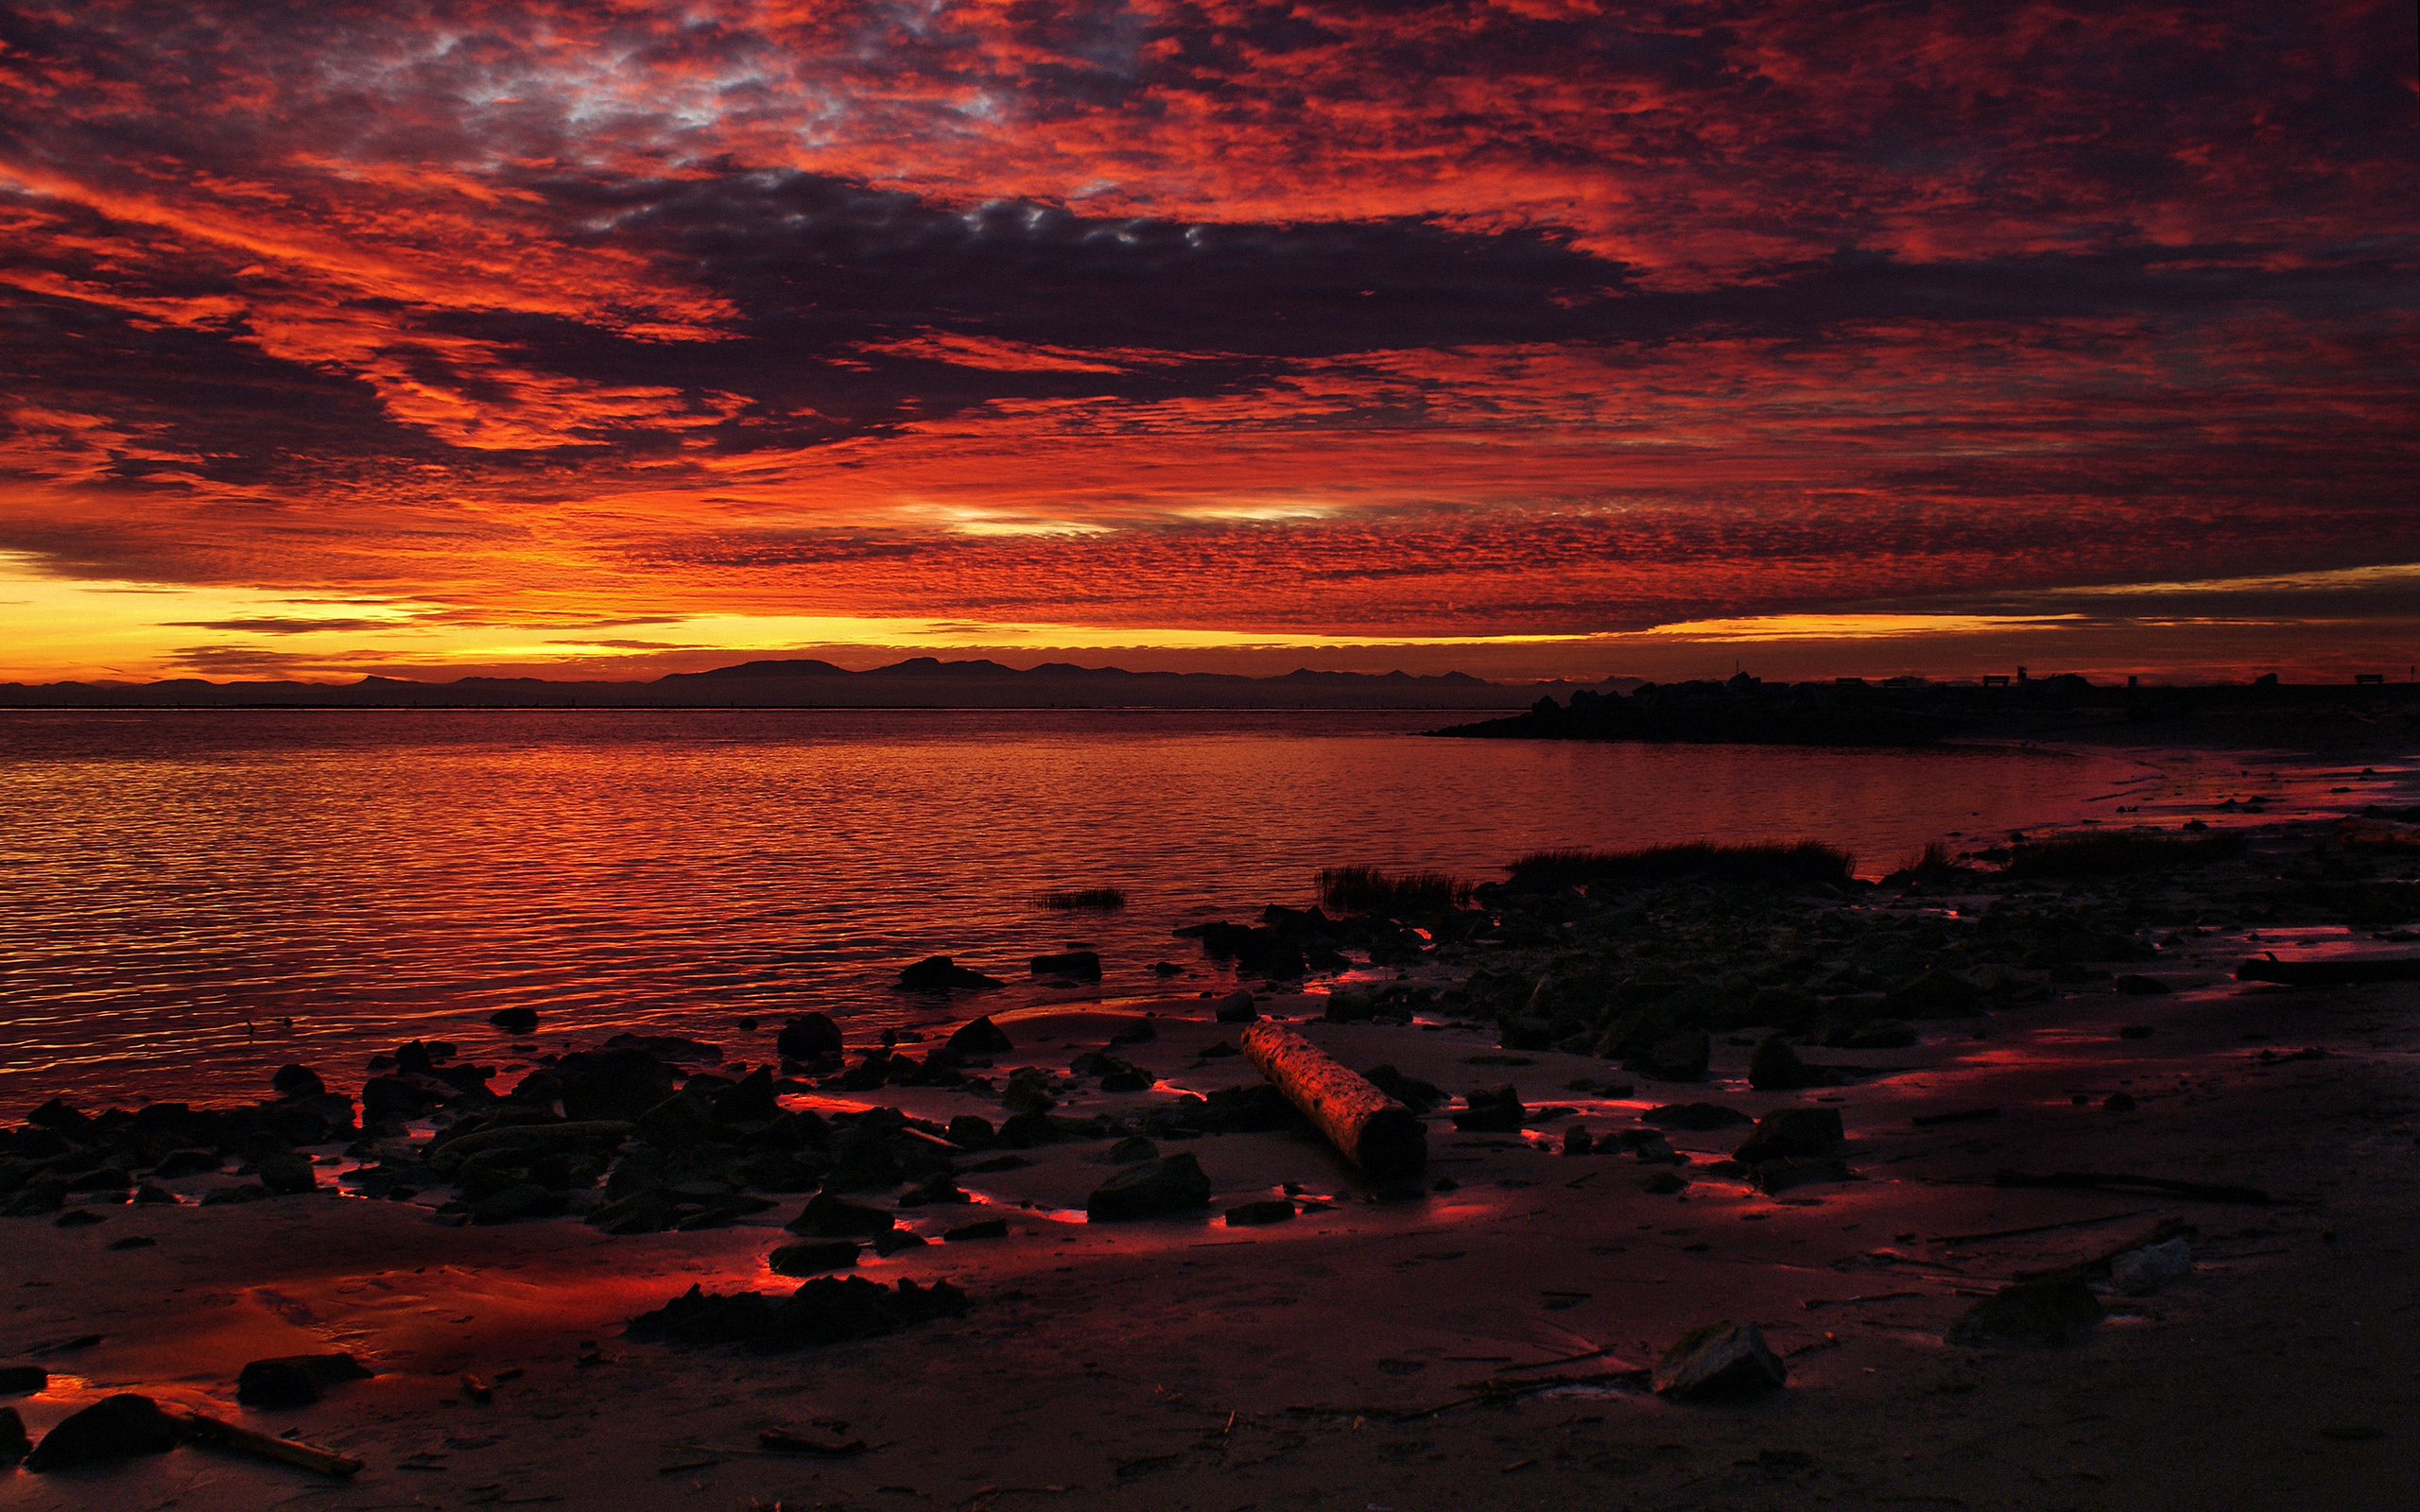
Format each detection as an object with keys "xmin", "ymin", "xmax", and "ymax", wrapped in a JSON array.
[{"xmin": 0, "ymin": 0, "xmax": 2420, "ymax": 682}]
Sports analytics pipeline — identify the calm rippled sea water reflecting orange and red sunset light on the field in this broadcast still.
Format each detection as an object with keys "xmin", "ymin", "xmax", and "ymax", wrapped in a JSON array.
[{"xmin": 0, "ymin": 709, "xmax": 2135, "ymax": 1118}]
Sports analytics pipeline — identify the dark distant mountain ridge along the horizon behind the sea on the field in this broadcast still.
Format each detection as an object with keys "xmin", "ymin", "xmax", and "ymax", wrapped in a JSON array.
[{"xmin": 0, "ymin": 656, "xmax": 1636, "ymax": 709}]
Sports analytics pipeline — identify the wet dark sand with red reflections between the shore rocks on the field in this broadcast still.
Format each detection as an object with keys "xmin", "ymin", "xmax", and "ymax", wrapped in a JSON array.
[{"xmin": 0, "ymin": 735, "xmax": 2420, "ymax": 1512}]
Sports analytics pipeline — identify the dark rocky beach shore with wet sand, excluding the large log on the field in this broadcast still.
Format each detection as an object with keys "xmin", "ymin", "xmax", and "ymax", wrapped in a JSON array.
[{"xmin": 0, "ymin": 779, "xmax": 2420, "ymax": 1512}]
